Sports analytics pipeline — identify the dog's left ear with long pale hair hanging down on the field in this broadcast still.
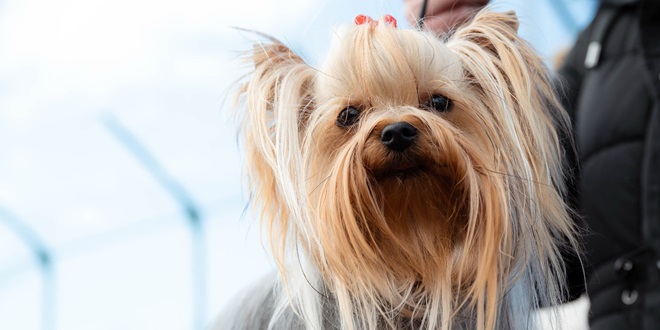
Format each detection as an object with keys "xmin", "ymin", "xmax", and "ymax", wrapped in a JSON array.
[{"xmin": 236, "ymin": 35, "xmax": 315, "ymax": 266}]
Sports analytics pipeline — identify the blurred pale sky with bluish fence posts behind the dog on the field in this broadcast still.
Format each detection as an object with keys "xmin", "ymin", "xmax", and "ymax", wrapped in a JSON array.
[{"xmin": 0, "ymin": 0, "xmax": 597, "ymax": 330}]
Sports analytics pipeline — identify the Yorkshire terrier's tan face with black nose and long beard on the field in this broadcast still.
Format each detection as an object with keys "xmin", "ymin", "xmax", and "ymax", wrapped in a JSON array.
[{"xmin": 302, "ymin": 24, "xmax": 488, "ymax": 292}]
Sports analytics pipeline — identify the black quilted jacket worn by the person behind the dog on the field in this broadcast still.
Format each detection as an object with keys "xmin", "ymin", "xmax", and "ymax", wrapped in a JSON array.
[{"xmin": 559, "ymin": 0, "xmax": 660, "ymax": 330}]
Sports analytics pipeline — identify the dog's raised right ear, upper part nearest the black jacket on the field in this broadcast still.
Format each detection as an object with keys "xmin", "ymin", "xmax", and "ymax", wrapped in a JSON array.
[{"xmin": 446, "ymin": 8, "xmax": 564, "ymax": 131}]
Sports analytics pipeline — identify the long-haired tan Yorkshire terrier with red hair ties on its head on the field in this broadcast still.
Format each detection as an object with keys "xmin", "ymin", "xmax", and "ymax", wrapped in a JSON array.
[{"xmin": 218, "ymin": 9, "xmax": 577, "ymax": 329}]
